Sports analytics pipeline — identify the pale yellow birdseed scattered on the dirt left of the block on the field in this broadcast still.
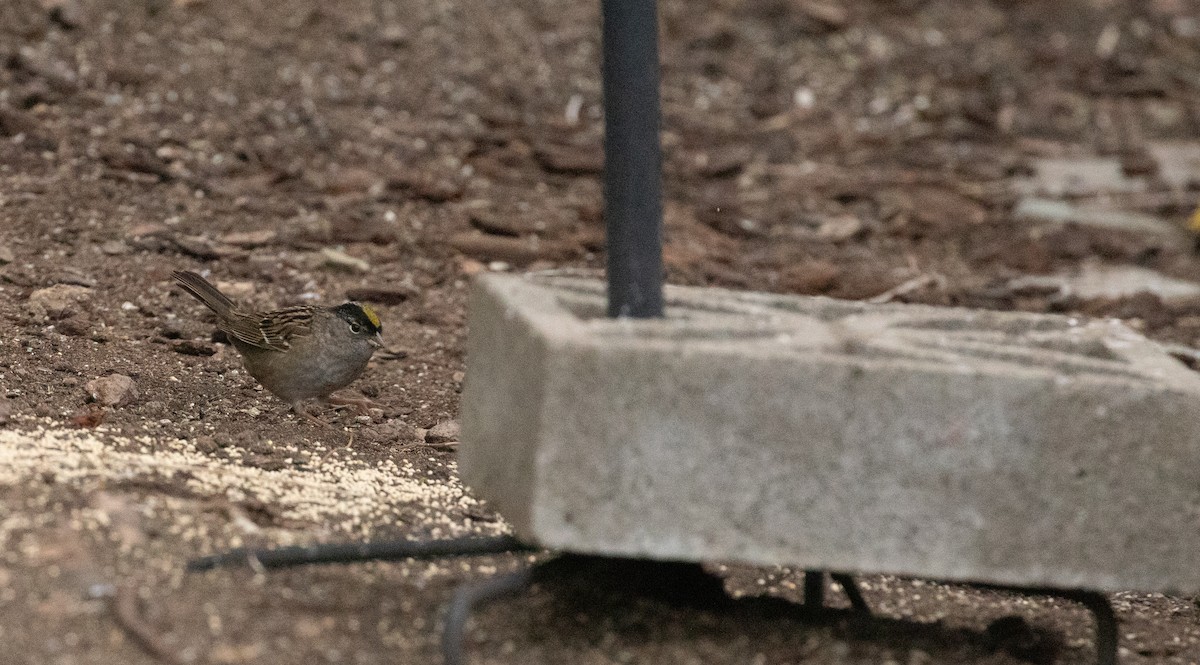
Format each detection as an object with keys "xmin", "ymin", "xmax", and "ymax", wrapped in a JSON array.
[{"xmin": 0, "ymin": 426, "xmax": 508, "ymax": 538}]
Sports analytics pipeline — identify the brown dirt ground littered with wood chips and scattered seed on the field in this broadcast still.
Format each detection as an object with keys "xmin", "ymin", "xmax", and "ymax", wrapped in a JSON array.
[{"xmin": 0, "ymin": 0, "xmax": 1200, "ymax": 665}]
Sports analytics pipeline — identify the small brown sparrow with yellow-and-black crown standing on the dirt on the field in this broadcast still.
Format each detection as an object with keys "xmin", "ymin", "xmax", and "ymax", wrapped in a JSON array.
[{"xmin": 172, "ymin": 270, "xmax": 383, "ymax": 419}]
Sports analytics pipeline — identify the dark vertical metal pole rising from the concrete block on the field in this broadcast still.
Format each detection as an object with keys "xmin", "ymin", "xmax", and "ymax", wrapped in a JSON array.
[{"xmin": 601, "ymin": 0, "xmax": 662, "ymax": 318}]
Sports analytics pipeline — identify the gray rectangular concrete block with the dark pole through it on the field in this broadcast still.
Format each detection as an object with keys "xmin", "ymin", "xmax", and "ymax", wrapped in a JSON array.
[{"xmin": 460, "ymin": 275, "xmax": 1200, "ymax": 594}]
